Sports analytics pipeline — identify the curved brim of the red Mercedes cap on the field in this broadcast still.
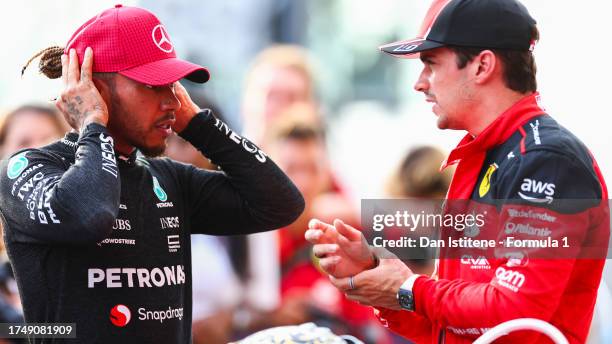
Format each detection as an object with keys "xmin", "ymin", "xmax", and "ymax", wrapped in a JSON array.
[{"xmin": 118, "ymin": 57, "xmax": 210, "ymax": 86}]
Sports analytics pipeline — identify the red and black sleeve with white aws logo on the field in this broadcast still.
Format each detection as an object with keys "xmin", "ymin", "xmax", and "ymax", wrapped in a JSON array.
[{"xmin": 413, "ymin": 151, "xmax": 603, "ymax": 331}]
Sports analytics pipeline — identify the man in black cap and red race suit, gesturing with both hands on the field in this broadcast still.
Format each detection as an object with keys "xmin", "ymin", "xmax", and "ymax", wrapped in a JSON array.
[{"xmin": 306, "ymin": 0, "xmax": 610, "ymax": 344}]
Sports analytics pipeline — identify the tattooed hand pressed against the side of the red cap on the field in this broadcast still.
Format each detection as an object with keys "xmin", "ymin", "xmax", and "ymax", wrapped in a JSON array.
[{"xmin": 55, "ymin": 48, "xmax": 108, "ymax": 130}]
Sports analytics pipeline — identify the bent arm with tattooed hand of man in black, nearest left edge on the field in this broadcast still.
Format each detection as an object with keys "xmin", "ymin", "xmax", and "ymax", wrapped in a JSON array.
[{"xmin": 0, "ymin": 48, "xmax": 120, "ymax": 244}]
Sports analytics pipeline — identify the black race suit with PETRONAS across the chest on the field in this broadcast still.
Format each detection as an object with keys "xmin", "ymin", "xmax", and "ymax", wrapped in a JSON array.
[{"xmin": 0, "ymin": 110, "xmax": 304, "ymax": 343}]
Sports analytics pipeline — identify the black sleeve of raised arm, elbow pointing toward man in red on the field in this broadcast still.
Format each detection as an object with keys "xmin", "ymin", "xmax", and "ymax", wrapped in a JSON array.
[{"xmin": 180, "ymin": 110, "xmax": 304, "ymax": 235}]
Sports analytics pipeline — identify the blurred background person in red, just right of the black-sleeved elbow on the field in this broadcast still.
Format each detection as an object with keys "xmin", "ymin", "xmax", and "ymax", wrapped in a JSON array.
[{"xmin": 266, "ymin": 103, "xmax": 387, "ymax": 343}]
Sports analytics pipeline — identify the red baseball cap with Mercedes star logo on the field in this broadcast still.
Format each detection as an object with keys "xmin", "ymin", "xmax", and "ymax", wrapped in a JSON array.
[{"xmin": 64, "ymin": 5, "xmax": 210, "ymax": 86}]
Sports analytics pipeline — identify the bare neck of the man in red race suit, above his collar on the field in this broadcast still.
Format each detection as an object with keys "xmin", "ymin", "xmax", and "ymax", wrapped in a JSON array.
[{"xmin": 467, "ymin": 87, "xmax": 531, "ymax": 137}]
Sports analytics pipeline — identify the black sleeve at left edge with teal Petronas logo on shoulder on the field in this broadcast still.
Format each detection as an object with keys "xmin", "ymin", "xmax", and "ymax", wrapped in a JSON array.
[{"xmin": 0, "ymin": 124, "xmax": 121, "ymax": 244}]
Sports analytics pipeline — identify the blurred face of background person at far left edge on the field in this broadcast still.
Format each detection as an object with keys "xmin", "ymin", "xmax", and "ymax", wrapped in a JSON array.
[{"xmin": 0, "ymin": 104, "xmax": 69, "ymax": 158}]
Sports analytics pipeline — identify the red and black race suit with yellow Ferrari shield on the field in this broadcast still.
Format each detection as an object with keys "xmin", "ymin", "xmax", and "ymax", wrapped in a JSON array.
[{"xmin": 376, "ymin": 93, "xmax": 610, "ymax": 344}]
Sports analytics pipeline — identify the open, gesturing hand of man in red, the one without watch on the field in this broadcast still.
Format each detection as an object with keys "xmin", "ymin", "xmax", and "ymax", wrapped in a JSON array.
[{"xmin": 304, "ymin": 219, "xmax": 377, "ymax": 278}]
